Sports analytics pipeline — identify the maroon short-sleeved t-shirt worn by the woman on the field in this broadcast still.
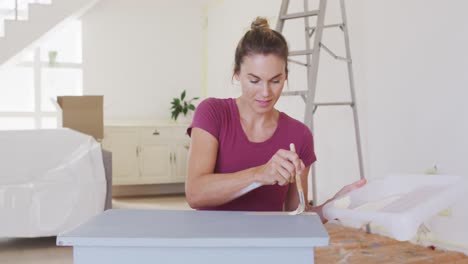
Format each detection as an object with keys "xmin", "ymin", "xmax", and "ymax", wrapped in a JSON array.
[{"xmin": 187, "ymin": 98, "xmax": 316, "ymax": 211}]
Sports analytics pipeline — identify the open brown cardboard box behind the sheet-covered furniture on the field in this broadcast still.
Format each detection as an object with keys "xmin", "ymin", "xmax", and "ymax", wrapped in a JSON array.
[{"xmin": 57, "ymin": 95, "xmax": 104, "ymax": 141}]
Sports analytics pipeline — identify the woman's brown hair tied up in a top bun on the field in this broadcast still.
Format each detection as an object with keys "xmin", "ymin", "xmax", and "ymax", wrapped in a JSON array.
[{"xmin": 234, "ymin": 17, "xmax": 289, "ymax": 76}]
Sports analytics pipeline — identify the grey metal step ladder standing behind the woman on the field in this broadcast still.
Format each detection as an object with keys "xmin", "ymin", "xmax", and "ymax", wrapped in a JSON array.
[{"xmin": 276, "ymin": 0, "xmax": 365, "ymax": 205}]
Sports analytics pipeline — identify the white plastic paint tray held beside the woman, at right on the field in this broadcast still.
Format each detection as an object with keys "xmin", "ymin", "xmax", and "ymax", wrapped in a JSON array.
[{"xmin": 323, "ymin": 174, "xmax": 468, "ymax": 241}]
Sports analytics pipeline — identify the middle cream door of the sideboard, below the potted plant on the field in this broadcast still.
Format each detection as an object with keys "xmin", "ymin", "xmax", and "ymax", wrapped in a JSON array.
[{"xmin": 139, "ymin": 143, "xmax": 173, "ymax": 183}]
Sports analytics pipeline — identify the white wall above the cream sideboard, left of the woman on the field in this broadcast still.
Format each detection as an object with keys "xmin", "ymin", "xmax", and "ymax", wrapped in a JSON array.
[{"xmin": 82, "ymin": 0, "xmax": 202, "ymax": 121}]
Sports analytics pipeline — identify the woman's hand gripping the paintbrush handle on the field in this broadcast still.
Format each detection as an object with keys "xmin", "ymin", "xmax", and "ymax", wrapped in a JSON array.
[{"xmin": 254, "ymin": 149, "xmax": 305, "ymax": 186}]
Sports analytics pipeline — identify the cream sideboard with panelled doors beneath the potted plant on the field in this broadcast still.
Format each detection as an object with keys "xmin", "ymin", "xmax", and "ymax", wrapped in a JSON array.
[{"xmin": 102, "ymin": 122, "xmax": 190, "ymax": 185}]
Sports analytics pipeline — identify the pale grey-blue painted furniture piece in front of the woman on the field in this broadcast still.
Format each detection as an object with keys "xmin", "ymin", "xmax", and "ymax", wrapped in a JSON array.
[{"xmin": 57, "ymin": 210, "xmax": 329, "ymax": 264}]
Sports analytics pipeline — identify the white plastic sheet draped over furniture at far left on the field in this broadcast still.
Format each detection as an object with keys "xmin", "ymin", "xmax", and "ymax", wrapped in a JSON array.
[{"xmin": 0, "ymin": 128, "xmax": 106, "ymax": 237}]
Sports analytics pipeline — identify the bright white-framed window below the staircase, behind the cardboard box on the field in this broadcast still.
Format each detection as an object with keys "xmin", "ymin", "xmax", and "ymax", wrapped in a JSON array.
[{"xmin": 0, "ymin": 21, "xmax": 83, "ymax": 130}]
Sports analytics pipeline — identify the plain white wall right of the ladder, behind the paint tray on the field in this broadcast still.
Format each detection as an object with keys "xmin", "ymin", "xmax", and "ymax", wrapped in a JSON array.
[{"xmin": 365, "ymin": 0, "xmax": 468, "ymax": 252}]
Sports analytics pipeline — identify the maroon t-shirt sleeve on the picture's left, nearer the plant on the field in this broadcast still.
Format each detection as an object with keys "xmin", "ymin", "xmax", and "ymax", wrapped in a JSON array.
[{"xmin": 187, "ymin": 98, "xmax": 221, "ymax": 140}]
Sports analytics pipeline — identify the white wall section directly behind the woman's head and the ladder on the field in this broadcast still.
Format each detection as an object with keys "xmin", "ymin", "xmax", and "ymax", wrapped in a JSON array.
[{"xmin": 206, "ymin": 0, "xmax": 366, "ymax": 201}]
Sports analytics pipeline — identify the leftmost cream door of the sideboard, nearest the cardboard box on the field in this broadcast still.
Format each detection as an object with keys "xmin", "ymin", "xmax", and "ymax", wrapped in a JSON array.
[{"xmin": 102, "ymin": 128, "xmax": 139, "ymax": 185}]
